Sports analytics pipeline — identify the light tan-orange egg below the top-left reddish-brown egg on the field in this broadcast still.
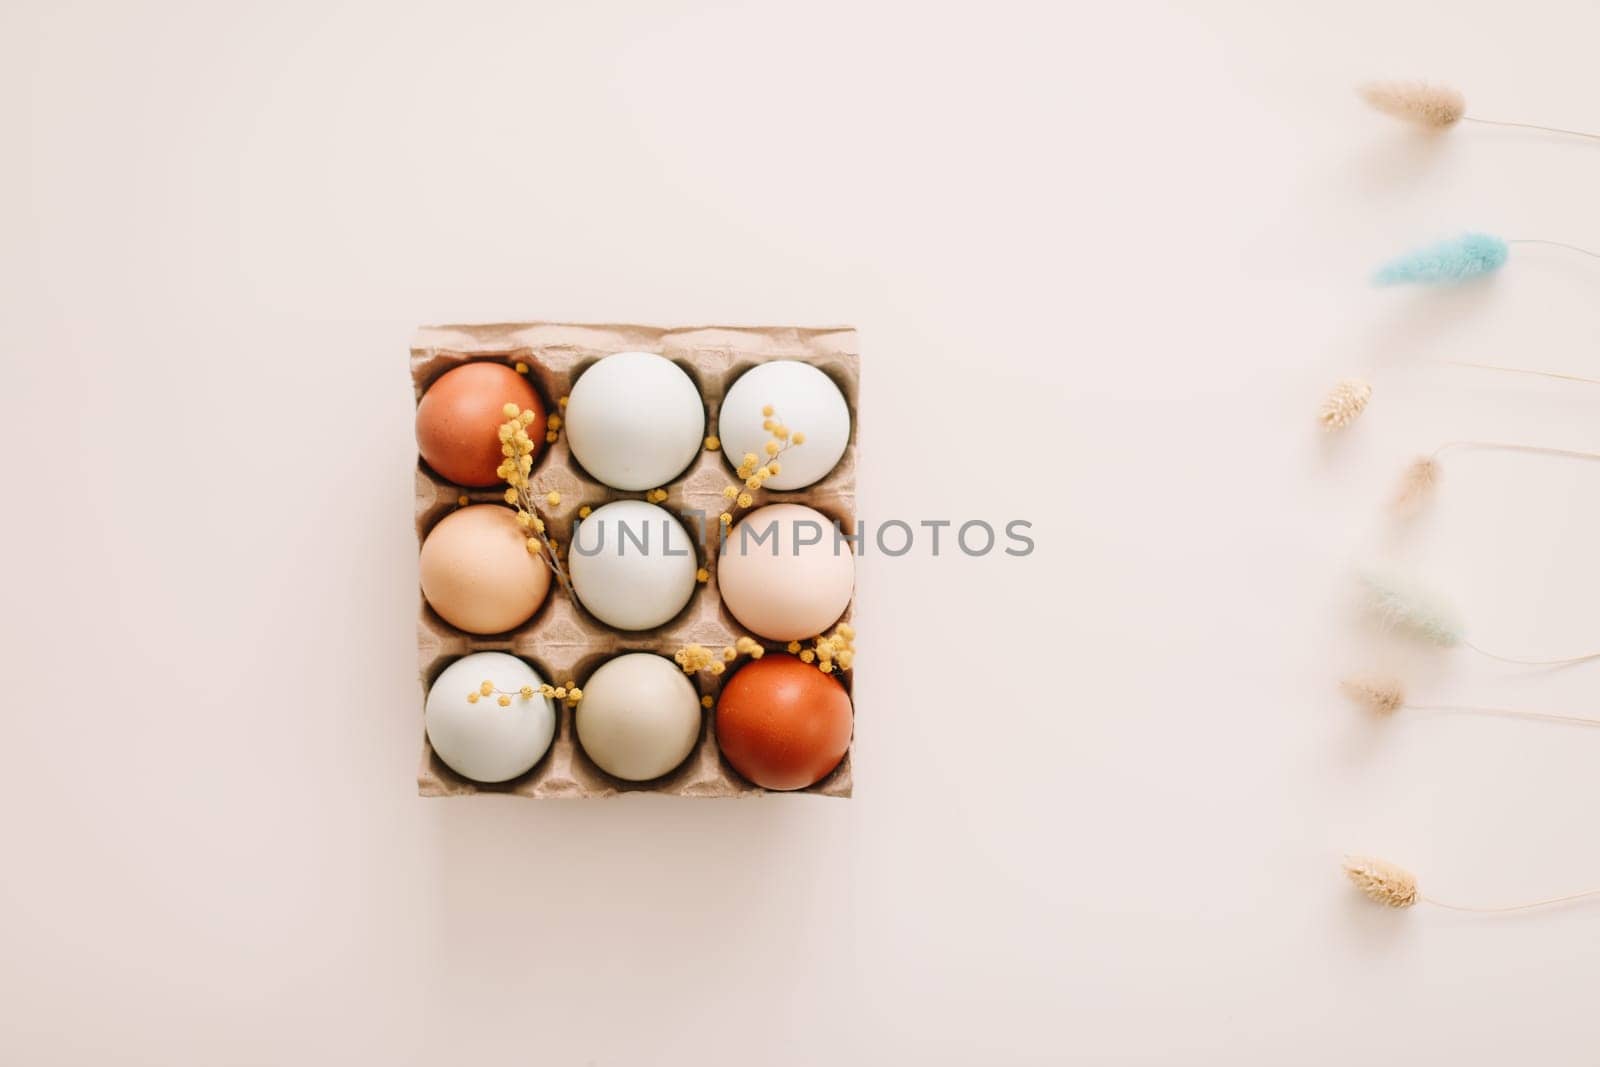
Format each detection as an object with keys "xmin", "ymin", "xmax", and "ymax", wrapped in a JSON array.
[{"xmin": 418, "ymin": 504, "xmax": 550, "ymax": 633}]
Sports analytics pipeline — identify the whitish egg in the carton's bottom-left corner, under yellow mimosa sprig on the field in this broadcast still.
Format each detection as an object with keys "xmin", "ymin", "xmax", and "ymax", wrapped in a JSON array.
[{"xmin": 424, "ymin": 653, "xmax": 555, "ymax": 782}]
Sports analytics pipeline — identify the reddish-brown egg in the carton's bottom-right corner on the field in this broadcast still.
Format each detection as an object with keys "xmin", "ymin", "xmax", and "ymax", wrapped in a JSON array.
[{"xmin": 717, "ymin": 654, "xmax": 851, "ymax": 789}]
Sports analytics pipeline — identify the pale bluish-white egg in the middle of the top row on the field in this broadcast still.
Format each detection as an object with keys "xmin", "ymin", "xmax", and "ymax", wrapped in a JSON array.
[{"xmin": 565, "ymin": 352, "xmax": 706, "ymax": 491}]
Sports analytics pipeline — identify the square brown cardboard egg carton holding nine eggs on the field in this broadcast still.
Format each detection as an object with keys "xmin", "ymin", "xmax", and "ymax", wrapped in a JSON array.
[{"xmin": 411, "ymin": 323, "xmax": 861, "ymax": 797}]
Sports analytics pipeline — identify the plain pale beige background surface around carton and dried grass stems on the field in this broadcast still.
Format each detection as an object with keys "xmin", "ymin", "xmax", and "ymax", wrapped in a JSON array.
[{"xmin": 0, "ymin": 0, "xmax": 1600, "ymax": 1065}]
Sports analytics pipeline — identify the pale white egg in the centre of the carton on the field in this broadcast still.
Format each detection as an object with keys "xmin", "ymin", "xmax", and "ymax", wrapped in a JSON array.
[{"xmin": 566, "ymin": 501, "xmax": 699, "ymax": 630}]
